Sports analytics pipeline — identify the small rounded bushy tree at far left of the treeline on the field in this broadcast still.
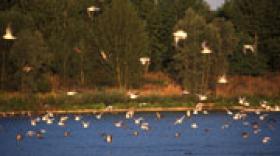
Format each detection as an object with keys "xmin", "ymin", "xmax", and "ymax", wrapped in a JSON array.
[{"xmin": 9, "ymin": 30, "xmax": 52, "ymax": 91}]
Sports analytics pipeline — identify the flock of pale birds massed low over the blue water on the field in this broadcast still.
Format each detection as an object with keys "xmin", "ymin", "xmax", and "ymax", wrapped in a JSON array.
[{"xmin": 2, "ymin": 97, "xmax": 280, "ymax": 144}]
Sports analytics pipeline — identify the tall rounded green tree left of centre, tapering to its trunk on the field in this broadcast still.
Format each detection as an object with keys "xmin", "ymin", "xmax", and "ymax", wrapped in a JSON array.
[{"xmin": 93, "ymin": 0, "xmax": 148, "ymax": 89}]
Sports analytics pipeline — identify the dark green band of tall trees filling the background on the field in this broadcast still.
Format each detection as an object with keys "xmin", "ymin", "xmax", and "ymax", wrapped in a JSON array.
[{"xmin": 0, "ymin": 0, "xmax": 280, "ymax": 93}]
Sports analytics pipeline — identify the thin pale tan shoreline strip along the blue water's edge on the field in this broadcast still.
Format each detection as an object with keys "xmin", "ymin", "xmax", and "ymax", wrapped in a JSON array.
[{"xmin": 0, "ymin": 106, "xmax": 280, "ymax": 117}]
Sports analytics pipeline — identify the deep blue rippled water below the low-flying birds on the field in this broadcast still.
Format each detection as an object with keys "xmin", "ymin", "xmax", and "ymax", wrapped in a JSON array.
[{"xmin": 0, "ymin": 113, "xmax": 280, "ymax": 156}]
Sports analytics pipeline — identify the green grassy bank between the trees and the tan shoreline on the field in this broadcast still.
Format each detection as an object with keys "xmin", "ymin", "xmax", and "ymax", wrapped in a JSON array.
[{"xmin": 0, "ymin": 92, "xmax": 280, "ymax": 112}]
